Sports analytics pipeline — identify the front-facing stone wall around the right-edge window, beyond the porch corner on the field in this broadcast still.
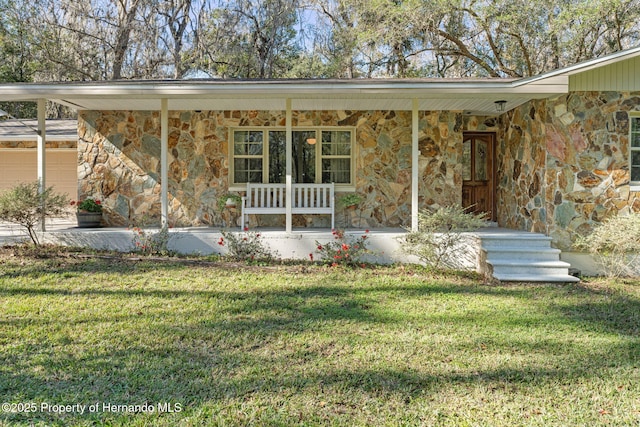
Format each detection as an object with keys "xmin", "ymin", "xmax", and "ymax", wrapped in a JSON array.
[{"xmin": 545, "ymin": 92, "xmax": 640, "ymax": 249}]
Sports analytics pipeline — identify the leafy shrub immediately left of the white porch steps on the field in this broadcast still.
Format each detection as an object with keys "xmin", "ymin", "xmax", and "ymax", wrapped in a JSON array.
[{"xmin": 400, "ymin": 205, "xmax": 487, "ymax": 269}]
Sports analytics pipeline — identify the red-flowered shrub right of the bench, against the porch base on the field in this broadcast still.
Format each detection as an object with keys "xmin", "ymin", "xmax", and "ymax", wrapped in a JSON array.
[{"xmin": 309, "ymin": 230, "xmax": 371, "ymax": 266}]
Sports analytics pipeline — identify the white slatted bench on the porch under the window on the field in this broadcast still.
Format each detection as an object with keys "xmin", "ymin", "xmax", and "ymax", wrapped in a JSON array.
[{"xmin": 241, "ymin": 183, "xmax": 335, "ymax": 230}]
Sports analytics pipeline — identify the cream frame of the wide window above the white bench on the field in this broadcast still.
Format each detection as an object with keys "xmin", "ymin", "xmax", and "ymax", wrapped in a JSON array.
[{"xmin": 228, "ymin": 126, "xmax": 357, "ymax": 192}]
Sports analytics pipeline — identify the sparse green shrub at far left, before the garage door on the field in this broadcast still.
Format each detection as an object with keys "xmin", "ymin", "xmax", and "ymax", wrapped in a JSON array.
[{"xmin": 0, "ymin": 181, "xmax": 68, "ymax": 245}]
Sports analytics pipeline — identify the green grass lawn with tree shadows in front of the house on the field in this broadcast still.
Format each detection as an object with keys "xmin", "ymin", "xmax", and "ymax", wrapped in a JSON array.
[{"xmin": 0, "ymin": 250, "xmax": 640, "ymax": 426}]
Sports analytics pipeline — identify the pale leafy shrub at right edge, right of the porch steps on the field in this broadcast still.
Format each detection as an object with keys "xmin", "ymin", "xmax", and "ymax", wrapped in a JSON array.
[{"xmin": 575, "ymin": 213, "xmax": 640, "ymax": 277}]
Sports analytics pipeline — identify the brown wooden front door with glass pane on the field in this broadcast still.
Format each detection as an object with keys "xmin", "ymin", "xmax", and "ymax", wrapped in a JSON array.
[{"xmin": 462, "ymin": 132, "xmax": 496, "ymax": 221}]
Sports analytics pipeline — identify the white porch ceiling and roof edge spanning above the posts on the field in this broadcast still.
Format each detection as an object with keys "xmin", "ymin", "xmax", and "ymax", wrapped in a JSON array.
[{"xmin": 0, "ymin": 78, "xmax": 567, "ymax": 115}]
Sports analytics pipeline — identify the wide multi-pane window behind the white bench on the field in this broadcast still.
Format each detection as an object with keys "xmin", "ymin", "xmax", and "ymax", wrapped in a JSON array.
[{"xmin": 231, "ymin": 128, "xmax": 354, "ymax": 189}]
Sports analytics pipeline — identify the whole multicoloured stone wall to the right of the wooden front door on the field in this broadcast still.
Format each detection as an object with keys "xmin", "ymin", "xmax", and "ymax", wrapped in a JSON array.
[{"xmin": 498, "ymin": 92, "xmax": 640, "ymax": 249}]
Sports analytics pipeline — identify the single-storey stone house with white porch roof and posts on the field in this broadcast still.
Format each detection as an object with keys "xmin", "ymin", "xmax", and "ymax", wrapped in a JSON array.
[{"xmin": 0, "ymin": 47, "xmax": 640, "ymax": 258}]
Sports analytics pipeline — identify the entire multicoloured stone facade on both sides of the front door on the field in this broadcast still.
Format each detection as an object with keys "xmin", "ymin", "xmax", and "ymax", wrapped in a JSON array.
[{"xmin": 78, "ymin": 92, "xmax": 640, "ymax": 249}]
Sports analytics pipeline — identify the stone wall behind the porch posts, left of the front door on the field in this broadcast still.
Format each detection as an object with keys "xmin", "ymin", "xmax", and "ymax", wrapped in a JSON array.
[{"xmin": 78, "ymin": 111, "xmax": 463, "ymax": 231}]
